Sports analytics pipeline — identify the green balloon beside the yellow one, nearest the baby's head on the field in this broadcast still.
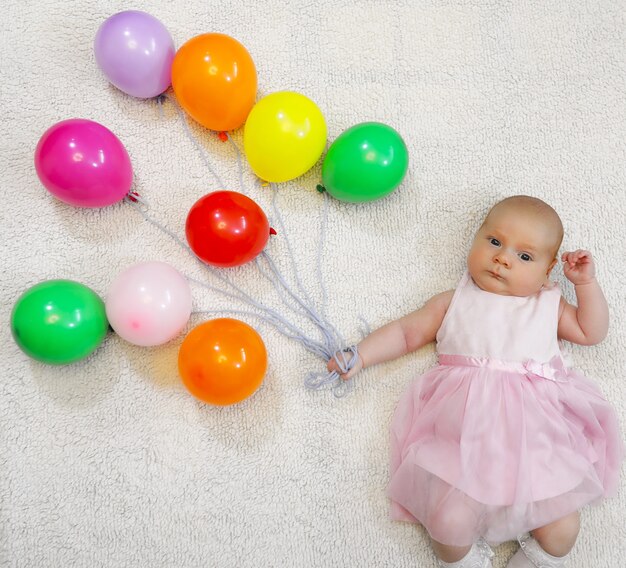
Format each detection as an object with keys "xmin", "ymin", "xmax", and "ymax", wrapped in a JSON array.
[{"xmin": 322, "ymin": 122, "xmax": 409, "ymax": 202}]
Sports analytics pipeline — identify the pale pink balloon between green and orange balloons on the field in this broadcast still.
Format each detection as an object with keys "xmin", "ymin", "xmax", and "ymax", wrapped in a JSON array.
[{"xmin": 106, "ymin": 262, "xmax": 191, "ymax": 347}]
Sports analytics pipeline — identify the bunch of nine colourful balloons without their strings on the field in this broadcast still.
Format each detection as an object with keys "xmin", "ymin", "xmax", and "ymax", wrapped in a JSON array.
[{"xmin": 11, "ymin": 6, "xmax": 408, "ymax": 404}]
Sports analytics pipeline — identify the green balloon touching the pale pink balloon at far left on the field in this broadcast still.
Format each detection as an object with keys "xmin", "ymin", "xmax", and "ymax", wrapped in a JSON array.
[{"xmin": 11, "ymin": 280, "xmax": 109, "ymax": 365}]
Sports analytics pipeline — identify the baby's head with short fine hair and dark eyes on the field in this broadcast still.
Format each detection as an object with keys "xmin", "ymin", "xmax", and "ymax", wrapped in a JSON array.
[{"xmin": 468, "ymin": 195, "xmax": 563, "ymax": 296}]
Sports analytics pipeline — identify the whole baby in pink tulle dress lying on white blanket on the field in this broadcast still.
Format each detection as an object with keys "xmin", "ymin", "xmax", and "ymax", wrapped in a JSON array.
[{"xmin": 328, "ymin": 196, "xmax": 623, "ymax": 568}]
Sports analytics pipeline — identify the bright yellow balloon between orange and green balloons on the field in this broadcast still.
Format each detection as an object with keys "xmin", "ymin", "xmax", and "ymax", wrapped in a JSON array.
[{"xmin": 243, "ymin": 91, "xmax": 326, "ymax": 182}]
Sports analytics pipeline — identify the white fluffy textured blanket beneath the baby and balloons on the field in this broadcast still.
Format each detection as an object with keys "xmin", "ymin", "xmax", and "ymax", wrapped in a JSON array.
[{"xmin": 0, "ymin": 0, "xmax": 626, "ymax": 568}]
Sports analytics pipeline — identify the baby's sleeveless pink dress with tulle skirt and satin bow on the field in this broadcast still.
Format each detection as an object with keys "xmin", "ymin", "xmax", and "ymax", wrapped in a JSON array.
[{"xmin": 388, "ymin": 274, "xmax": 623, "ymax": 546}]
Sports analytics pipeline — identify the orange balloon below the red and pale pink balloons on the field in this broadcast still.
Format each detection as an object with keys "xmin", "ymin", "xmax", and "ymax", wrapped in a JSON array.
[{"xmin": 178, "ymin": 318, "xmax": 267, "ymax": 406}]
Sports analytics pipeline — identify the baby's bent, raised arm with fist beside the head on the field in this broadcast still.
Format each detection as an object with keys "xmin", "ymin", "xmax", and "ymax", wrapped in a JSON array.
[{"xmin": 558, "ymin": 250, "xmax": 609, "ymax": 345}]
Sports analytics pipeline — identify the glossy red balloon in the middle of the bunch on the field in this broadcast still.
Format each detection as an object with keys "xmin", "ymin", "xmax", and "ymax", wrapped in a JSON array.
[{"xmin": 185, "ymin": 191, "xmax": 270, "ymax": 268}]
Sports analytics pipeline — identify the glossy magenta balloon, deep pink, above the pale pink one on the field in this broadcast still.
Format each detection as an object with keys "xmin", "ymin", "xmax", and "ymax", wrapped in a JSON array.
[{"xmin": 35, "ymin": 118, "xmax": 133, "ymax": 207}]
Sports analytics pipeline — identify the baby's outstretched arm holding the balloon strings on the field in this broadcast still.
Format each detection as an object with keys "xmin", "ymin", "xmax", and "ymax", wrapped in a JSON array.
[{"xmin": 328, "ymin": 290, "xmax": 454, "ymax": 380}]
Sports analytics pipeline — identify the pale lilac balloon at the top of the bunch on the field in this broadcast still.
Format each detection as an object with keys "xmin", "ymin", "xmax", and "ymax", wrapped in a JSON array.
[{"xmin": 94, "ymin": 10, "xmax": 176, "ymax": 99}]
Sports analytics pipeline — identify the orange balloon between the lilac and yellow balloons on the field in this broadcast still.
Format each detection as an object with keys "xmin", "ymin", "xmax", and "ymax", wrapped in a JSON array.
[{"xmin": 172, "ymin": 33, "xmax": 257, "ymax": 131}]
